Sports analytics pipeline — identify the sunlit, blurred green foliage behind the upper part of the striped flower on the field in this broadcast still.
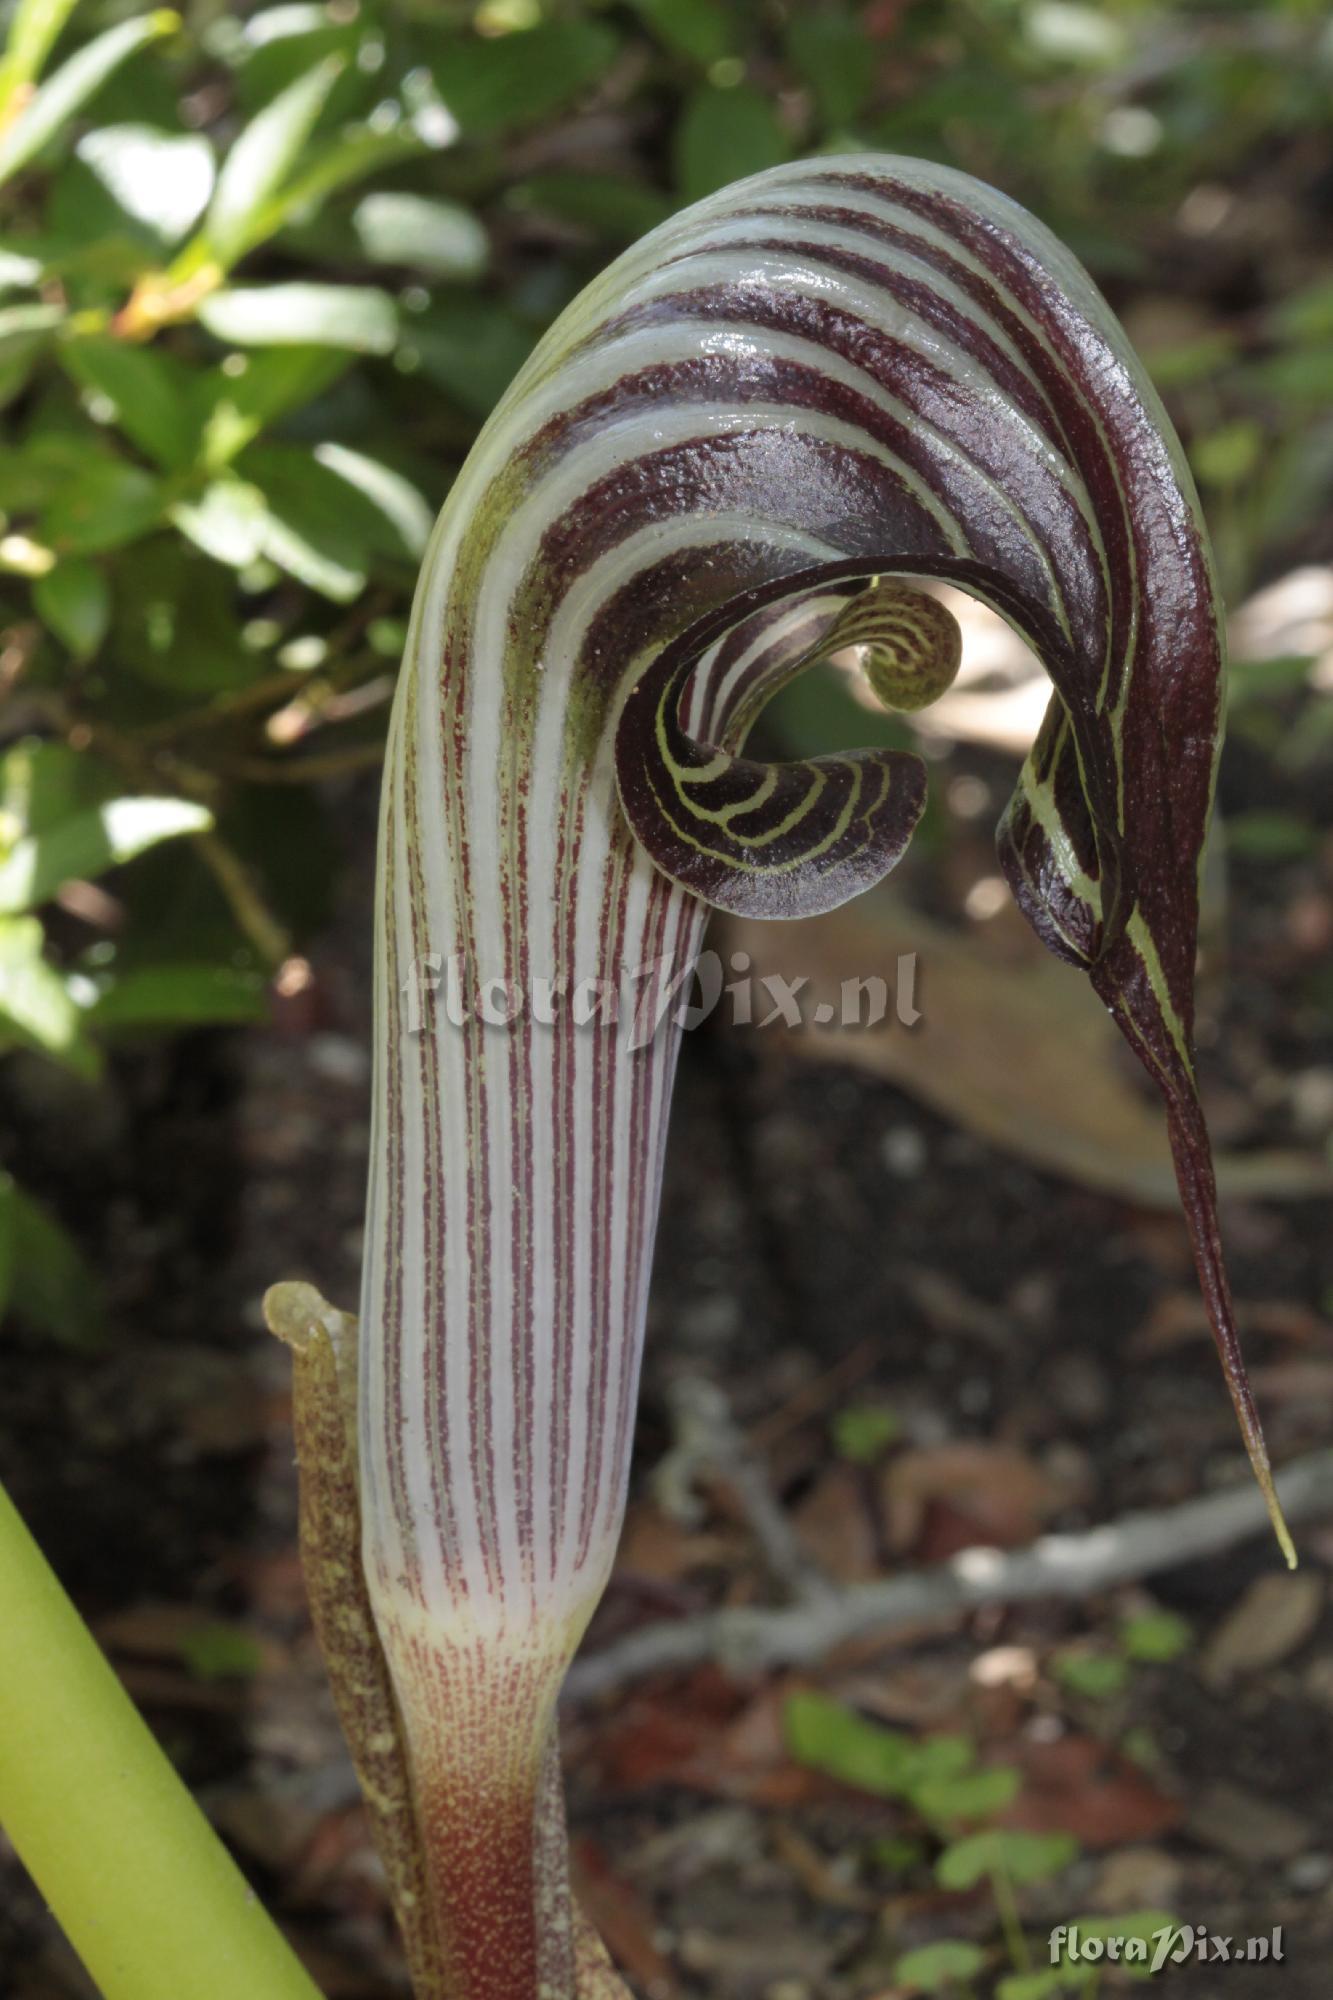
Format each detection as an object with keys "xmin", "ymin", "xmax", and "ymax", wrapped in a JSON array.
[{"xmin": 0, "ymin": 0, "xmax": 1333, "ymax": 1338}]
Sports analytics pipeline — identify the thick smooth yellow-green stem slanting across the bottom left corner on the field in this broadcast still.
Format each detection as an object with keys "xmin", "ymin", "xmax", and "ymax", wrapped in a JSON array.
[{"xmin": 0, "ymin": 1488, "xmax": 318, "ymax": 2000}]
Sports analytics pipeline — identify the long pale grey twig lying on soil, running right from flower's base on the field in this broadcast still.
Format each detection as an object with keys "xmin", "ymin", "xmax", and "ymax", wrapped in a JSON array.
[{"xmin": 566, "ymin": 1450, "xmax": 1333, "ymax": 1700}]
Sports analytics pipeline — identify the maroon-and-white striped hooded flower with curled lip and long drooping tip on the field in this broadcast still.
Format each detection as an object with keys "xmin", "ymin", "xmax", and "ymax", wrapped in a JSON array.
[{"xmin": 358, "ymin": 156, "xmax": 1271, "ymax": 2000}]
